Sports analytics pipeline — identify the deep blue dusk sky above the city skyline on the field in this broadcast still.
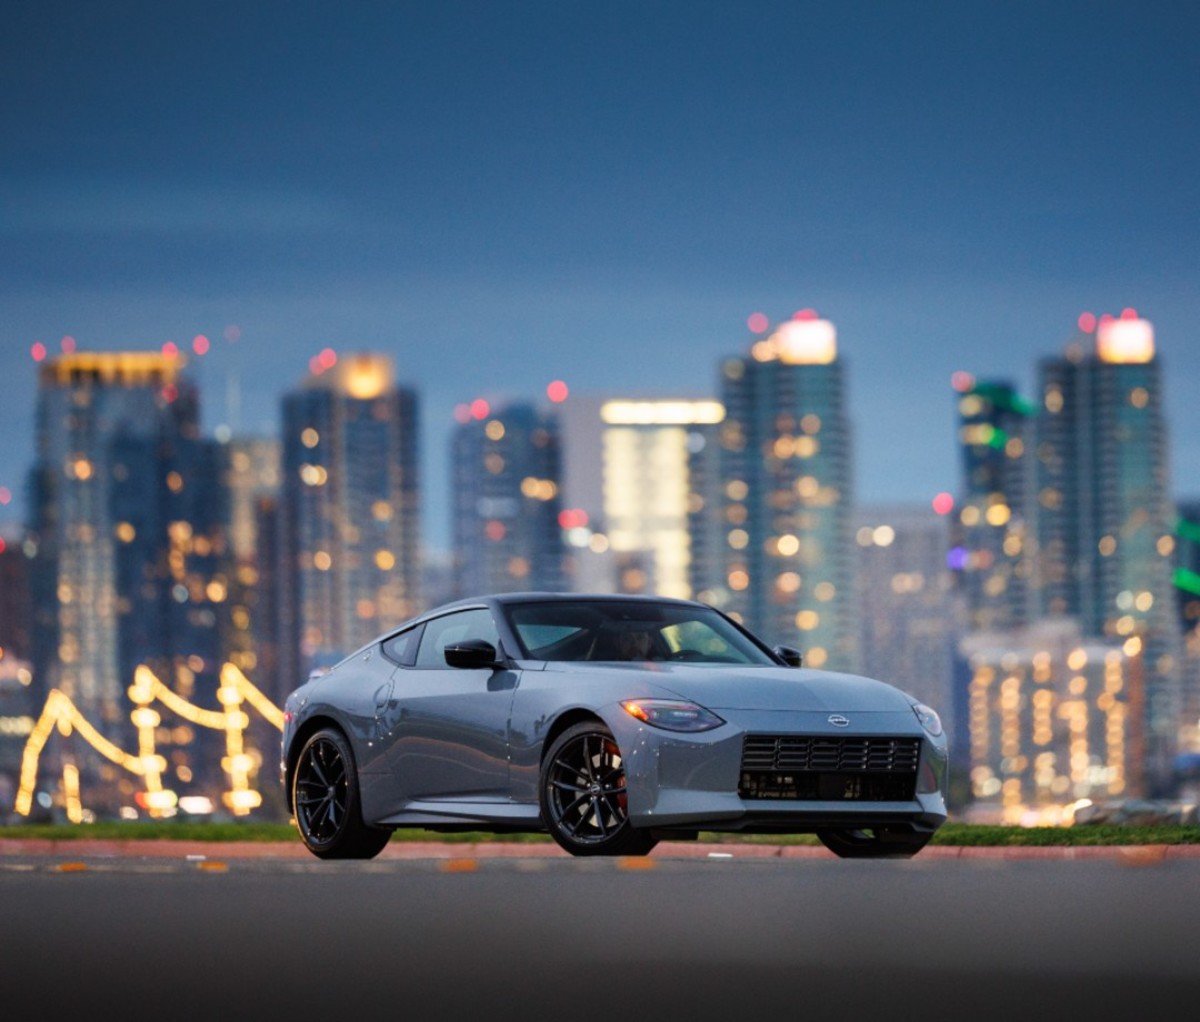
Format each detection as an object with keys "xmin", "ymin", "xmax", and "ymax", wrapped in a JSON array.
[{"xmin": 0, "ymin": 0, "xmax": 1200, "ymax": 546}]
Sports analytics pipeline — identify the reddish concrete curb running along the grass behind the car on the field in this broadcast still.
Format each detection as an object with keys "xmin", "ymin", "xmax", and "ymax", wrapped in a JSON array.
[{"xmin": 0, "ymin": 837, "xmax": 1200, "ymax": 865}]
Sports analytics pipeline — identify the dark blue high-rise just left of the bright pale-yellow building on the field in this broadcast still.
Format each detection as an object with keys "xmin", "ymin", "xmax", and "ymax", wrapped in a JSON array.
[{"xmin": 450, "ymin": 398, "xmax": 568, "ymax": 596}]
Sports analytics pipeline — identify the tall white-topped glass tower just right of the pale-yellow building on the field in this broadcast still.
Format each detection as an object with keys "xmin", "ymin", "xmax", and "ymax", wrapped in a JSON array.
[{"xmin": 698, "ymin": 311, "xmax": 858, "ymax": 671}]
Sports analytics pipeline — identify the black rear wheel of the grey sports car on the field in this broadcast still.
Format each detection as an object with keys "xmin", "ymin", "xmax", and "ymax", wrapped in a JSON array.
[{"xmin": 292, "ymin": 727, "xmax": 391, "ymax": 859}]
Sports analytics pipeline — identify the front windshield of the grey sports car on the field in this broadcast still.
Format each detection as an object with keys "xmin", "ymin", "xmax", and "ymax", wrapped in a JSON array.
[{"xmin": 506, "ymin": 600, "xmax": 775, "ymax": 665}]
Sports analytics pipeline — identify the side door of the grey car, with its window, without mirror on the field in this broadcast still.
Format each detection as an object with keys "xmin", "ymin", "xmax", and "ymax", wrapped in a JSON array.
[{"xmin": 383, "ymin": 607, "xmax": 517, "ymax": 811}]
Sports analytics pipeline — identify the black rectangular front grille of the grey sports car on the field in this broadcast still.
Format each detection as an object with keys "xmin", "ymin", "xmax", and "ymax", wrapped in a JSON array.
[{"xmin": 738, "ymin": 734, "xmax": 920, "ymax": 802}]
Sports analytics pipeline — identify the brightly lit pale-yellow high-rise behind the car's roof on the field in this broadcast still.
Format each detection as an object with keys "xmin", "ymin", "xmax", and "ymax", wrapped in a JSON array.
[{"xmin": 600, "ymin": 399, "xmax": 725, "ymax": 599}]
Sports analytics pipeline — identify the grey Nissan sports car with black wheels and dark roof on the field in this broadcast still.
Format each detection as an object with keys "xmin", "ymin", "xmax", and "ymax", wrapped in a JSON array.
[{"xmin": 281, "ymin": 593, "xmax": 947, "ymax": 859}]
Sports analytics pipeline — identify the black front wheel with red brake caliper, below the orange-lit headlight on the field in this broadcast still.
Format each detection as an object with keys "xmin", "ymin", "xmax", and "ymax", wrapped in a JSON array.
[{"xmin": 538, "ymin": 721, "xmax": 659, "ymax": 855}]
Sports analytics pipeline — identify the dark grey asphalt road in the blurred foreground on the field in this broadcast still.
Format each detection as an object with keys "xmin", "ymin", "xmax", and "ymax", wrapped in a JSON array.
[{"xmin": 0, "ymin": 855, "xmax": 1200, "ymax": 1022}]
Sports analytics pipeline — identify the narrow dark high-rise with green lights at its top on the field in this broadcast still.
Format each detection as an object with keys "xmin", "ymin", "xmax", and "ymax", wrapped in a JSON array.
[{"xmin": 952, "ymin": 373, "xmax": 1036, "ymax": 631}]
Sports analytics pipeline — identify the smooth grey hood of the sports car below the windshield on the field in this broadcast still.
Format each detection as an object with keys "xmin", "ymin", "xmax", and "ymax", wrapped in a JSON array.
[{"xmin": 544, "ymin": 662, "xmax": 913, "ymax": 713}]
